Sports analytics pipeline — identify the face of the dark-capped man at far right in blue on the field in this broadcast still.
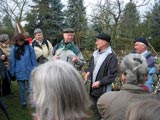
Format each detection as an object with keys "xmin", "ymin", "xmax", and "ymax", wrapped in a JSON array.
[{"xmin": 134, "ymin": 42, "xmax": 147, "ymax": 54}]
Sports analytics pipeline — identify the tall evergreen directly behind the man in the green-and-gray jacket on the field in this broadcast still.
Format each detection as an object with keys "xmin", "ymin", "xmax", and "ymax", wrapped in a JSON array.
[{"xmin": 65, "ymin": 0, "xmax": 88, "ymax": 46}]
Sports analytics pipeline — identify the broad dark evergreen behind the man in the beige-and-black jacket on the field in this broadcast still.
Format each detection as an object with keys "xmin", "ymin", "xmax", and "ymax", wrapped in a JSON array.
[{"xmin": 27, "ymin": 0, "xmax": 64, "ymax": 42}]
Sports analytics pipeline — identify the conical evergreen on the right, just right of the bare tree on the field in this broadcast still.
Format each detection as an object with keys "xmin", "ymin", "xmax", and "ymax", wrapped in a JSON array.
[{"xmin": 120, "ymin": 0, "xmax": 140, "ymax": 38}]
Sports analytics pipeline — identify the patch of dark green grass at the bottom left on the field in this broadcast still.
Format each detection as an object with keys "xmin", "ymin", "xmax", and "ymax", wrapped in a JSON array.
[{"xmin": 0, "ymin": 81, "xmax": 33, "ymax": 120}]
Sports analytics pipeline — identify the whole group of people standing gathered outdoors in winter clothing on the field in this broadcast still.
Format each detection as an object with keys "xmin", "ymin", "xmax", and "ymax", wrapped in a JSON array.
[{"xmin": 0, "ymin": 28, "xmax": 160, "ymax": 120}]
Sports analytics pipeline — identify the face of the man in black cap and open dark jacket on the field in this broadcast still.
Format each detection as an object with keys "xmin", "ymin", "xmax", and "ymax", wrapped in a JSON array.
[{"xmin": 96, "ymin": 39, "xmax": 108, "ymax": 51}]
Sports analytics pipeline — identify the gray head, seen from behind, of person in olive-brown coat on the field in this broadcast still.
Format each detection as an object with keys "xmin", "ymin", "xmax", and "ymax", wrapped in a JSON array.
[{"xmin": 120, "ymin": 53, "xmax": 148, "ymax": 85}]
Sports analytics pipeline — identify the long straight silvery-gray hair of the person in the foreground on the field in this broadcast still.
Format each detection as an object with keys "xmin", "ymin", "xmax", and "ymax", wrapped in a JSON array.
[{"xmin": 31, "ymin": 60, "xmax": 89, "ymax": 120}]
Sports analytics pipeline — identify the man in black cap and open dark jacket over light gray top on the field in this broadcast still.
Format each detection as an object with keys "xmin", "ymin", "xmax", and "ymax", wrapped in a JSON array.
[{"xmin": 84, "ymin": 33, "xmax": 118, "ymax": 120}]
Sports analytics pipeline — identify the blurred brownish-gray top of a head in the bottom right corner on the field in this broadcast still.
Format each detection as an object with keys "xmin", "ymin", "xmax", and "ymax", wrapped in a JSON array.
[{"xmin": 126, "ymin": 99, "xmax": 160, "ymax": 120}]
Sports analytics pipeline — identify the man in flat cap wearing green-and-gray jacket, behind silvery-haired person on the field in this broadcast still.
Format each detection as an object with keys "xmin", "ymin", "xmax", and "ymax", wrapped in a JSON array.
[{"xmin": 50, "ymin": 28, "xmax": 85, "ymax": 70}]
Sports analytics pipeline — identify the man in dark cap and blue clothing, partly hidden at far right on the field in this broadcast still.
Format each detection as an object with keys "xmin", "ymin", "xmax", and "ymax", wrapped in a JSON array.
[{"xmin": 134, "ymin": 37, "xmax": 156, "ymax": 92}]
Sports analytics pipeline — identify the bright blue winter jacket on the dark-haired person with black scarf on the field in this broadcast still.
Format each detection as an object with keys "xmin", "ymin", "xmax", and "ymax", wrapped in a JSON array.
[{"xmin": 10, "ymin": 45, "xmax": 37, "ymax": 80}]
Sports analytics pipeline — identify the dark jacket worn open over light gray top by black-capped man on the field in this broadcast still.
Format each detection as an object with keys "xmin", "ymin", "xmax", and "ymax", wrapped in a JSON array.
[{"xmin": 87, "ymin": 53, "xmax": 118, "ymax": 97}]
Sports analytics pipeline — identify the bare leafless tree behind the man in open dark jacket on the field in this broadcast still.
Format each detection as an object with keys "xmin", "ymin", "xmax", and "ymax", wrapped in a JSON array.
[{"xmin": 91, "ymin": 0, "xmax": 150, "ymax": 45}]
